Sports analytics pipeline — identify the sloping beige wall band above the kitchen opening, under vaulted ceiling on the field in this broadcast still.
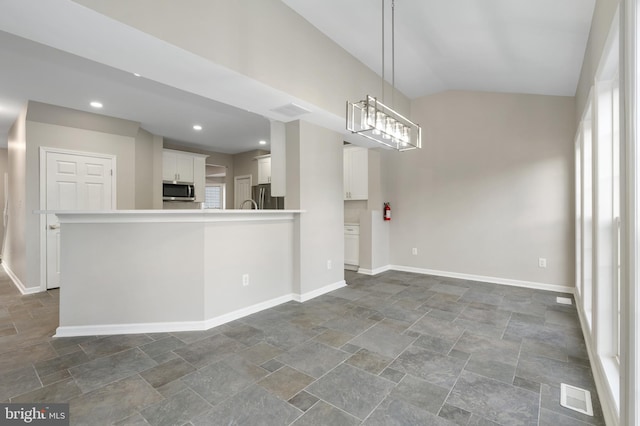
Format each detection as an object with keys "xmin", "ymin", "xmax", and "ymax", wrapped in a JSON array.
[{"xmin": 76, "ymin": 0, "xmax": 409, "ymax": 116}]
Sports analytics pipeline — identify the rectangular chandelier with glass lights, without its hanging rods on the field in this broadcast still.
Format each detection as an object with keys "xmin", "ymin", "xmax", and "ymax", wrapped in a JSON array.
[{"xmin": 347, "ymin": 95, "xmax": 422, "ymax": 151}]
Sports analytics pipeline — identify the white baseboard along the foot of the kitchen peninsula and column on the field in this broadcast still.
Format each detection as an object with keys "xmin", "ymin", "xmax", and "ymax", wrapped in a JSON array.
[{"xmin": 53, "ymin": 280, "xmax": 347, "ymax": 337}]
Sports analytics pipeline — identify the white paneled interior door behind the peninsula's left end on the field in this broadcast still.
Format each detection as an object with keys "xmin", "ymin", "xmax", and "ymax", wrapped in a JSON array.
[{"xmin": 45, "ymin": 151, "xmax": 115, "ymax": 288}]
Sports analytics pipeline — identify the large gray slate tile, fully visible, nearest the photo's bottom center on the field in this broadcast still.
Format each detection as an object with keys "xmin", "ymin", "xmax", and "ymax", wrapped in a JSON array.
[{"xmin": 306, "ymin": 364, "xmax": 394, "ymax": 419}]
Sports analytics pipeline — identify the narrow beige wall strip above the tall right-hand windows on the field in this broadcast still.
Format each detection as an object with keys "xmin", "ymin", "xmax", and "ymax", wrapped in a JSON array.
[{"xmin": 575, "ymin": 0, "xmax": 620, "ymax": 118}]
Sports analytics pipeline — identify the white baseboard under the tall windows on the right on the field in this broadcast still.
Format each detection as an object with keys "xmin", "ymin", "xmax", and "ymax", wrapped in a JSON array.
[{"xmin": 574, "ymin": 293, "xmax": 620, "ymax": 426}]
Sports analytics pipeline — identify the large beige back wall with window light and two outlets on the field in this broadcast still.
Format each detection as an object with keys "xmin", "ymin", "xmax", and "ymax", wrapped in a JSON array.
[{"xmin": 382, "ymin": 92, "xmax": 575, "ymax": 286}]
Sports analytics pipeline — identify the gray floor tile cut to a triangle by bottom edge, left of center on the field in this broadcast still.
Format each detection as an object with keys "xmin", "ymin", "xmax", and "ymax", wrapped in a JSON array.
[{"xmin": 191, "ymin": 385, "xmax": 302, "ymax": 426}]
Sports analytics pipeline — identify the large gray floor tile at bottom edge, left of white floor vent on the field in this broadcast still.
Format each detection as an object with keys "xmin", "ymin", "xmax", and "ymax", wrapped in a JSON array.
[{"xmin": 447, "ymin": 371, "xmax": 539, "ymax": 426}]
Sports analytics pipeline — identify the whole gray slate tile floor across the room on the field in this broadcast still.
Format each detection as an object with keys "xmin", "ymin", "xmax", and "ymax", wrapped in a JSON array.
[{"xmin": 0, "ymin": 272, "xmax": 604, "ymax": 426}]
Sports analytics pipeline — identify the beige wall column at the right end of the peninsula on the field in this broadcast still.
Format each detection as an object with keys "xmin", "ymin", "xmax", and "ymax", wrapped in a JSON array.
[{"xmin": 285, "ymin": 121, "xmax": 344, "ymax": 294}]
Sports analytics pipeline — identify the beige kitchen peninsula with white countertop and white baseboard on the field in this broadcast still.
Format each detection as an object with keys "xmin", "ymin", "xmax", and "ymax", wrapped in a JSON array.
[{"xmin": 50, "ymin": 210, "xmax": 345, "ymax": 337}]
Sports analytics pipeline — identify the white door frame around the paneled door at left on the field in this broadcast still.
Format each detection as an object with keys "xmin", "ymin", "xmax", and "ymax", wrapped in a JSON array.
[{"xmin": 39, "ymin": 146, "xmax": 118, "ymax": 291}]
